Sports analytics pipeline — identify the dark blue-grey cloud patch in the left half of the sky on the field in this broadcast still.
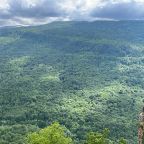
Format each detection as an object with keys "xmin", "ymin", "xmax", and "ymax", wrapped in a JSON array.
[{"xmin": 9, "ymin": 0, "xmax": 62, "ymax": 18}]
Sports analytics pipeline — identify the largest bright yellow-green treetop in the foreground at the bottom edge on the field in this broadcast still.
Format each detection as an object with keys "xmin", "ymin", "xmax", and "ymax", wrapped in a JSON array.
[{"xmin": 27, "ymin": 123, "xmax": 72, "ymax": 144}]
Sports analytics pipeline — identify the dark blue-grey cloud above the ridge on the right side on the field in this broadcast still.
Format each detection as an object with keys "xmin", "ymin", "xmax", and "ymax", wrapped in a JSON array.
[{"xmin": 91, "ymin": 2, "xmax": 144, "ymax": 20}]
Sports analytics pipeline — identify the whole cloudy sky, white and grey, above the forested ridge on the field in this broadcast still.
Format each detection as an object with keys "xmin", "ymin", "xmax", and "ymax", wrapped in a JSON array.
[{"xmin": 0, "ymin": 0, "xmax": 144, "ymax": 26}]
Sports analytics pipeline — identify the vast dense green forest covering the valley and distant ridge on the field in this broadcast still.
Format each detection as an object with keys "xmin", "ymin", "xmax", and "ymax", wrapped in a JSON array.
[{"xmin": 0, "ymin": 21, "xmax": 144, "ymax": 144}]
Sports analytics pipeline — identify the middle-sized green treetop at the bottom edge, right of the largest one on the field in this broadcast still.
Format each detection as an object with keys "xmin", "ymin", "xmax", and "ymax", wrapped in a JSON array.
[{"xmin": 86, "ymin": 129, "xmax": 109, "ymax": 144}]
